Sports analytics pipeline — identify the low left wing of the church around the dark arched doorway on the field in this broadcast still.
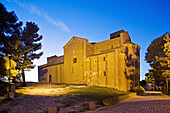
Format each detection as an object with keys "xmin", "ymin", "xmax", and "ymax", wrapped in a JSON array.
[{"xmin": 38, "ymin": 56, "xmax": 64, "ymax": 83}]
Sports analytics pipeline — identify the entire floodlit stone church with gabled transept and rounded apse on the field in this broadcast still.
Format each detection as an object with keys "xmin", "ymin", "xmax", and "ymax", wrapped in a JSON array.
[{"xmin": 38, "ymin": 30, "xmax": 140, "ymax": 91}]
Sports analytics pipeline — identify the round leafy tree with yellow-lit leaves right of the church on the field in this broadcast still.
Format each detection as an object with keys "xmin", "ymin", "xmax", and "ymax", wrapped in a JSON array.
[{"xmin": 145, "ymin": 33, "xmax": 169, "ymax": 85}]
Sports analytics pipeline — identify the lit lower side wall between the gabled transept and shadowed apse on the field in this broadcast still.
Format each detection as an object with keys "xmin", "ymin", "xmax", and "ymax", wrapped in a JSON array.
[{"xmin": 86, "ymin": 50, "xmax": 130, "ymax": 91}]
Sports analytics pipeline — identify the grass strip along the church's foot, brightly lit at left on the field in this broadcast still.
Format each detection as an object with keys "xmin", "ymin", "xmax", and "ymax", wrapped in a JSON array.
[{"xmin": 16, "ymin": 84, "xmax": 130, "ymax": 101}]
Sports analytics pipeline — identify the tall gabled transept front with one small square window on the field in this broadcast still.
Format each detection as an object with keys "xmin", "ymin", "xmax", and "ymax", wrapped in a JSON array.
[{"xmin": 64, "ymin": 37, "xmax": 86, "ymax": 84}]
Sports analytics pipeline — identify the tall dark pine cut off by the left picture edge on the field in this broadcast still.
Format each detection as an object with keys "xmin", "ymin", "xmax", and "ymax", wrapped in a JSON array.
[{"xmin": 0, "ymin": 3, "xmax": 22, "ymax": 79}]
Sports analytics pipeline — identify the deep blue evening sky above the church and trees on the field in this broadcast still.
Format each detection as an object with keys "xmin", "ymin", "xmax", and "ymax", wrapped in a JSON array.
[{"xmin": 1, "ymin": 0, "xmax": 170, "ymax": 81}]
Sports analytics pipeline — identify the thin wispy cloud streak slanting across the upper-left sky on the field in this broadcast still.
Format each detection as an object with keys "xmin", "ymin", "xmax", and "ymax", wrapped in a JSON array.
[{"xmin": 9, "ymin": 0, "xmax": 71, "ymax": 33}]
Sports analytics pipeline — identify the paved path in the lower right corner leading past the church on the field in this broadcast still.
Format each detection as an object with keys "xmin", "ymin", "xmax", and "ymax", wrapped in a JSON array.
[{"xmin": 98, "ymin": 91, "xmax": 170, "ymax": 113}]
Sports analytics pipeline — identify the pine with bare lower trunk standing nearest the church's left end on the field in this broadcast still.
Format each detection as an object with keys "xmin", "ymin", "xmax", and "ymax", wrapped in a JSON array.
[{"xmin": 8, "ymin": 22, "xmax": 43, "ymax": 86}]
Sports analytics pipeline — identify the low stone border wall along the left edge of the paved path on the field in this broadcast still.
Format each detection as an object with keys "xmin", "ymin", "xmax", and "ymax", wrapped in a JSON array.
[{"xmin": 103, "ymin": 93, "xmax": 136, "ymax": 106}]
